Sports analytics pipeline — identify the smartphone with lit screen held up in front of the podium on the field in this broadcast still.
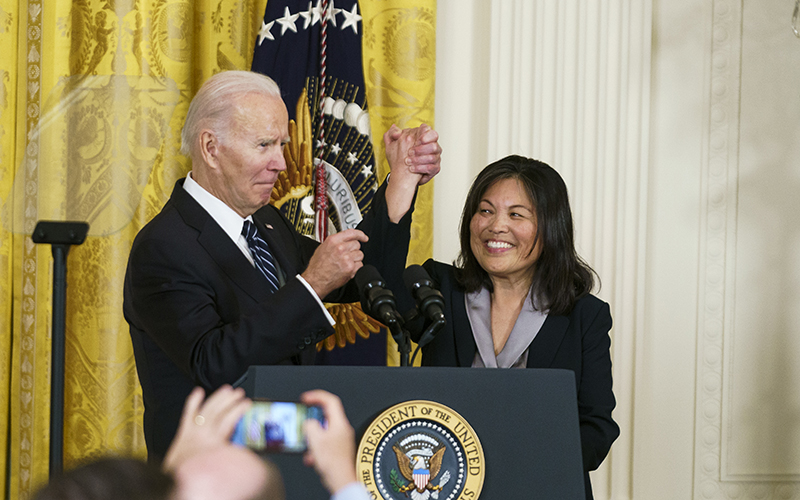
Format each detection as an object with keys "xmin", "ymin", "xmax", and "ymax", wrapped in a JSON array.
[{"xmin": 231, "ymin": 400, "xmax": 325, "ymax": 453}]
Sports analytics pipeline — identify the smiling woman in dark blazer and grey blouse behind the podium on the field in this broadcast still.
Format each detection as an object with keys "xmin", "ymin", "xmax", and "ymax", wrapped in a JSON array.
[{"xmin": 398, "ymin": 156, "xmax": 619, "ymax": 498}]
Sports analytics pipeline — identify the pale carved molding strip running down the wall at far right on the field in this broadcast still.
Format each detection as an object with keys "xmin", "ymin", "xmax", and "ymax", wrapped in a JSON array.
[{"xmin": 693, "ymin": 0, "xmax": 800, "ymax": 500}]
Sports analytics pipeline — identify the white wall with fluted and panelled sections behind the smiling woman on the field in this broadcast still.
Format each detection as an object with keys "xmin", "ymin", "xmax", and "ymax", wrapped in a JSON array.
[{"xmin": 434, "ymin": 0, "xmax": 800, "ymax": 499}]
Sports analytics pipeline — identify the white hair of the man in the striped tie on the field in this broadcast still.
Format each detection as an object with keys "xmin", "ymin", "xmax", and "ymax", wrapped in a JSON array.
[{"xmin": 181, "ymin": 71, "xmax": 281, "ymax": 158}]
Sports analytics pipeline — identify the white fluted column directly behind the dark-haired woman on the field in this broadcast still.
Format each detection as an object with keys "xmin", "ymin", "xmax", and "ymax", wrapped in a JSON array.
[{"xmin": 434, "ymin": 0, "xmax": 652, "ymax": 499}]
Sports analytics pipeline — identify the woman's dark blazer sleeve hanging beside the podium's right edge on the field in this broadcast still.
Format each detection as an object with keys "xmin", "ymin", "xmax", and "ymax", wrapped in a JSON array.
[{"xmin": 578, "ymin": 303, "xmax": 619, "ymax": 470}]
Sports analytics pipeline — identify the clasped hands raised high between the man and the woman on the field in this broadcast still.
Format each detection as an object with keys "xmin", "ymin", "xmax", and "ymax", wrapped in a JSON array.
[{"xmin": 383, "ymin": 124, "xmax": 442, "ymax": 186}]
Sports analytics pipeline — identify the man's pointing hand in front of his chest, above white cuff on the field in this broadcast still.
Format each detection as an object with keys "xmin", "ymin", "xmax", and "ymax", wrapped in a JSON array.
[{"xmin": 301, "ymin": 229, "xmax": 369, "ymax": 299}]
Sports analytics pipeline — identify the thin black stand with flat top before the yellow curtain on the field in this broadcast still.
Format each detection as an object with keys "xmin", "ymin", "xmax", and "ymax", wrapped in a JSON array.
[{"xmin": 31, "ymin": 221, "xmax": 89, "ymax": 478}]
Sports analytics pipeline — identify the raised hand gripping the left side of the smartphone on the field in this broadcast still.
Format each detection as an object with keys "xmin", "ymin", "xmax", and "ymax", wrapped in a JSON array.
[{"xmin": 163, "ymin": 385, "xmax": 251, "ymax": 471}]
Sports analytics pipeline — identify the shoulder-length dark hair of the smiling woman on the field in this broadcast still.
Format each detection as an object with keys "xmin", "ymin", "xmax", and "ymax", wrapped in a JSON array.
[{"xmin": 455, "ymin": 155, "xmax": 596, "ymax": 315}]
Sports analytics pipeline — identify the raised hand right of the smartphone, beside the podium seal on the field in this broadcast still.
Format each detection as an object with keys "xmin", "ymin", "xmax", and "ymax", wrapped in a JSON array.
[{"xmin": 300, "ymin": 390, "xmax": 356, "ymax": 495}]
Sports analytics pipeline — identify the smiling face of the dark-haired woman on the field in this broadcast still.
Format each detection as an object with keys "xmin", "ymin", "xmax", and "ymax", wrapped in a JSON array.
[{"xmin": 469, "ymin": 179, "xmax": 542, "ymax": 286}]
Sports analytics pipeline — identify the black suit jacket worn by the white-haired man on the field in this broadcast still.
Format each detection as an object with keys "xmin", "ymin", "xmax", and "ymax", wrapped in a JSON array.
[{"xmin": 123, "ymin": 180, "xmax": 411, "ymax": 461}]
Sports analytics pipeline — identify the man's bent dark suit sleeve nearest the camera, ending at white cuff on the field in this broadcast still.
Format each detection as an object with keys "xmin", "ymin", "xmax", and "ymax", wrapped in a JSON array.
[{"xmin": 125, "ymin": 230, "xmax": 332, "ymax": 390}]
